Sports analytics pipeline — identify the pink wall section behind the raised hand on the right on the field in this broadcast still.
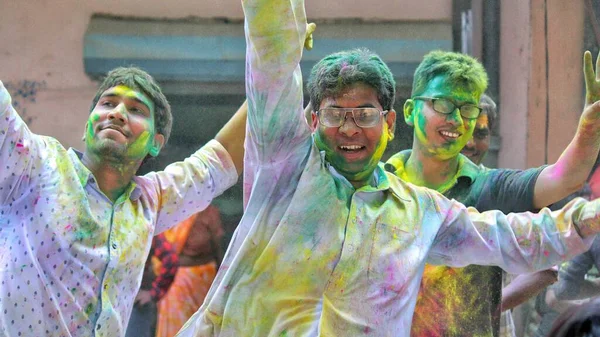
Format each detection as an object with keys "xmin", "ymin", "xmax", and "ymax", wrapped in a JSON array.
[{"xmin": 499, "ymin": 0, "xmax": 585, "ymax": 168}]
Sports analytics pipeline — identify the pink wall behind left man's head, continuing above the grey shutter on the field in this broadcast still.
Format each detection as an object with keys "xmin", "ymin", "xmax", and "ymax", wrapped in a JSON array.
[{"xmin": 0, "ymin": 0, "xmax": 452, "ymax": 147}]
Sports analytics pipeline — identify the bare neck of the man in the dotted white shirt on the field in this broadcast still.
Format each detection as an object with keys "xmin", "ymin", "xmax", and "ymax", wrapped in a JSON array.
[{"xmin": 81, "ymin": 152, "xmax": 142, "ymax": 202}]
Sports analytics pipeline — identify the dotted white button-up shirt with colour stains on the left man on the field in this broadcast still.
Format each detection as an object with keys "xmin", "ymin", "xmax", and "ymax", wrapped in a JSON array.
[{"xmin": 0, "ymin": 82, "xmax": 237, "ymax": 337}]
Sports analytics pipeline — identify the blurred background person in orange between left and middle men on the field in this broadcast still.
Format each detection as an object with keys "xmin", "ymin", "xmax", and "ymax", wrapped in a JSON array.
[{"xmin": 156, "ymin": 205, "xmax": 224, "ymax": 337}]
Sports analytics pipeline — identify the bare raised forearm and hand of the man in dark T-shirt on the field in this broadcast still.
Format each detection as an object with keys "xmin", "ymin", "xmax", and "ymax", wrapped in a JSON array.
[{"xmin": 534, "ymin": 51, "xmax": 600, "ymax": 208}]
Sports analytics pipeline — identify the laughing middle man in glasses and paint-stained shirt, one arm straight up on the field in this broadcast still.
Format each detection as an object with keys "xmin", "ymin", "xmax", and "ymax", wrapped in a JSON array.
[{"xmin": 178, "ymin": 0, "xmax": 600, "ymax": 337}]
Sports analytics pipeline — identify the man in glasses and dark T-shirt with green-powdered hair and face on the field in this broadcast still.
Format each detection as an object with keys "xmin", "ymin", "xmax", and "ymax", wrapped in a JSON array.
[{"xmin": 386, "ymin": 51, "xmax": 600, "ymax": 336}]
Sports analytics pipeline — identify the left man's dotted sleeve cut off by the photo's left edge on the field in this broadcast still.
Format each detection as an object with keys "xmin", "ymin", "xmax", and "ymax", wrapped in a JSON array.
[{"xmin": 0, "ymin": 81, "xmax": 45, "ymax": 206}]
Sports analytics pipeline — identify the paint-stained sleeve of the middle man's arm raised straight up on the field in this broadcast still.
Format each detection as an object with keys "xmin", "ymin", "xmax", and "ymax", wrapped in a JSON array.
[{"xmin": 243, "ymin": 0, "xmax": 311, "ymax": 171}]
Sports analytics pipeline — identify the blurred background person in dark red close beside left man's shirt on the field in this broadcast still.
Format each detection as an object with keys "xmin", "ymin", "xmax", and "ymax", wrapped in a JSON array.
[{"xmin": 125, "ymin": 234, "xmax": 179, "ymax": 337}]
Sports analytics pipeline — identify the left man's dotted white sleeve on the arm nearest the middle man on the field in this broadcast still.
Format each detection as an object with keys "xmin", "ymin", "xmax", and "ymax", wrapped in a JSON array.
[{"xmin": 145, "ymin": 140, "xmax": 238, "ymax": 235}]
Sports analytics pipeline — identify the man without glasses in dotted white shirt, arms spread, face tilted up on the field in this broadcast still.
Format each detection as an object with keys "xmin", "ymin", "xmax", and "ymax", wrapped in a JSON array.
[{"xmin": 0, "ymin": 68, "xmax": 246, "ymax": 337}]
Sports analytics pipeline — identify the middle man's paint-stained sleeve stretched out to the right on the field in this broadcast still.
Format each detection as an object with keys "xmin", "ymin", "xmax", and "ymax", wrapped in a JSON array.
[{"xmin": 428, "ymin": 191, "xmax": 600, "ymax": 274}]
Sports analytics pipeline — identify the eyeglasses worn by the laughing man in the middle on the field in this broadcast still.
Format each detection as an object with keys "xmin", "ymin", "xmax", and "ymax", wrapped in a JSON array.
[{"xmin": 315, "ymin": 108, "xmax": 388, "ymax": 128}]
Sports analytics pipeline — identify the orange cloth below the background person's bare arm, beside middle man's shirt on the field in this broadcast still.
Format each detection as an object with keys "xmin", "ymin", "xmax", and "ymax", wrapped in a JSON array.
[{"xmin": 156, "ymin": 262, "xmax": 217, "ymax": 337}]
